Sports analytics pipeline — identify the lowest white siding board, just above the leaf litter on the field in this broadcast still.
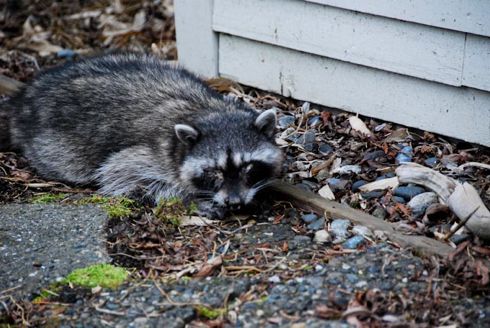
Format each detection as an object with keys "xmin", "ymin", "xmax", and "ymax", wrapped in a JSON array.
[{"xmin": 219, "ymin": 35, "xmax": 490, "ymax": 146}]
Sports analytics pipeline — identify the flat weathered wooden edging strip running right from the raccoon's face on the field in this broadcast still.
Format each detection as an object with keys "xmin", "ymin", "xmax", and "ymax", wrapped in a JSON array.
[{"xmin": 271, "ymin": 181, "xmax": 453, "ymax": 257}]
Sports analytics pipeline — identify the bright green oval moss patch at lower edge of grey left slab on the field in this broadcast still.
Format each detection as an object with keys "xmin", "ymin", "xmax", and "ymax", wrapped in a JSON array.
[{"xmin": 63, "ymin": 264, "xmax": 129, "ymax": 288}]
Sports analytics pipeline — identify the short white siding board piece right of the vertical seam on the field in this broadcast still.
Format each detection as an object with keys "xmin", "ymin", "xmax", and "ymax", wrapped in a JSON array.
[{"xmin": 463, "ymin": 35, "xmax": 490, "ymax": 91}]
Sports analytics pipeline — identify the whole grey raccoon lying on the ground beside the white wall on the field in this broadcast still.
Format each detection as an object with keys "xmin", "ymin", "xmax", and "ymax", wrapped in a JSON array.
[{"xmin": 5, "ymin": 53, "xmax": 283, "ymax": 218}]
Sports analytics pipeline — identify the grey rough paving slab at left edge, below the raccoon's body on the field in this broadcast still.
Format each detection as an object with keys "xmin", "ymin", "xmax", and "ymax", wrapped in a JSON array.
[{"xmin": 0, "ymin": 204, "xmax": 110, "ymax": 297}]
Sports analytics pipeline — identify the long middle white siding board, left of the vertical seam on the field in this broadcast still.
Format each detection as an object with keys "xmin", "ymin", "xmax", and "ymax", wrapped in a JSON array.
[{"xmin": 213, "ymin": 0, "xmax": 465, "ymax": 86}]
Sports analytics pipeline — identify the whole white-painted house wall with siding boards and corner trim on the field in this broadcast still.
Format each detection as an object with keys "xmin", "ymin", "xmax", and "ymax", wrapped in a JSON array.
[{"xmin": 175, "ymin": 0, "xmax": 490, "ymax": 146}]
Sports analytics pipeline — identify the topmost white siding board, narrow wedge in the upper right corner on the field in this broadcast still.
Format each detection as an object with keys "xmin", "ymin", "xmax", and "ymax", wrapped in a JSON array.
[{"xmin": 305, "ymin": 0, "xmax": 490, "ymax": 36}]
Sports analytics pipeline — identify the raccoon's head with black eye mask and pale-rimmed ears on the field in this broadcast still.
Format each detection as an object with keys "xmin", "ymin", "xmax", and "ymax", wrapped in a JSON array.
[{"xmin": 175, "ymin": 110, "xmax": 283, "ymax": 209}]
